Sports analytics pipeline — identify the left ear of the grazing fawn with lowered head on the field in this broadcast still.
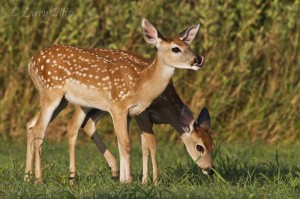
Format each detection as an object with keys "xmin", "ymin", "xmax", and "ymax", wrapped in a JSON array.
[{"xmin": 180, "ymin": 105, "xmax": 195, "ymax": 133}]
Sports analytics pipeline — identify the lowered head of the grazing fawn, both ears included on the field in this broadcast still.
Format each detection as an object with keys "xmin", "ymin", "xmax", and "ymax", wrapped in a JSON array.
[{"xmin": 181, "ymin": 105, "xmax": 214, "ymax": 175}]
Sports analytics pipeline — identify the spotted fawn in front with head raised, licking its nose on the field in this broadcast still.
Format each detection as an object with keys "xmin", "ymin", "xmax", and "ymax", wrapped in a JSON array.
[{"xmin": 25, "ymin": 19, "xmax": 204, "ymax": 183}]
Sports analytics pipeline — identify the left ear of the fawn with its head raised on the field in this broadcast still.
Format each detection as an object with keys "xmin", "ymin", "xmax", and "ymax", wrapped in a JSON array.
[{"xmin": 142, "ymin": 18, "xmax": 163, "ymax": 46}]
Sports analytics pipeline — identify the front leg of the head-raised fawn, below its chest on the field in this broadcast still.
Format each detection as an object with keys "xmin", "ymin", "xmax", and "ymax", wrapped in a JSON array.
[{"xmin": 111, "ymin": 109, "xmax": 132, "ymax": 183}]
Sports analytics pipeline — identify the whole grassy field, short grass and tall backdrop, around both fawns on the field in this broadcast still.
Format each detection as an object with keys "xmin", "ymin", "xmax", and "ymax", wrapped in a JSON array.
[{"xmin": 0, "ymin": 0, "xmax": 300, "ymax": 198}]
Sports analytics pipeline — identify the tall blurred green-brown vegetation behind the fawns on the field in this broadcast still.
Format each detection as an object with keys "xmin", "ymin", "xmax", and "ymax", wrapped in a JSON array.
[{"xmin": 0, "ymin": 0, "xmax": 300, "ymax": 142}]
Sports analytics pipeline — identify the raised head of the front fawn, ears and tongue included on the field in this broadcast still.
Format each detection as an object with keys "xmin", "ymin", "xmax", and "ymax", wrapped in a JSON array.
[{"xmin": 142, "ymin": 19, "xmax": 204, "ymax": 70}]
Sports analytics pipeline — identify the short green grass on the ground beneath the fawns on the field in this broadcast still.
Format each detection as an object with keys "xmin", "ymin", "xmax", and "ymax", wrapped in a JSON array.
[{"xmin": 0, "ymin": 140, "xmax": 300, "ymax": 198}]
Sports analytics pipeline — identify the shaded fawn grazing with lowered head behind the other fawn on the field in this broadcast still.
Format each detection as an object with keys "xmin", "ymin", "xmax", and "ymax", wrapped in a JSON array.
[{"xmin": 67, "ymin": 49, "xmax": 214, "ymax": 183}]
